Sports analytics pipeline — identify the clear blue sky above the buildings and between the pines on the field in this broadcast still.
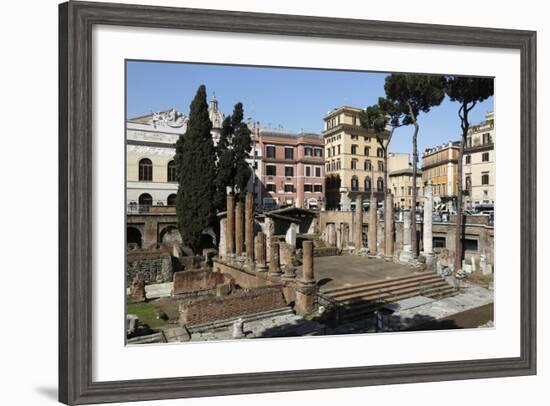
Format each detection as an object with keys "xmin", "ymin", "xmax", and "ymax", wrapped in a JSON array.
[{"xmin": 127, "ymin": 61, "xmax": 493, "ymax": 153}]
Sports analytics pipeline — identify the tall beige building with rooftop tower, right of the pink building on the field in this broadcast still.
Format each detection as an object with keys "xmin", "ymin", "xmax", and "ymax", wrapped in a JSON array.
[{"xmin": 323, "ymin": 106, "xmax": 387, "ymax": 210}]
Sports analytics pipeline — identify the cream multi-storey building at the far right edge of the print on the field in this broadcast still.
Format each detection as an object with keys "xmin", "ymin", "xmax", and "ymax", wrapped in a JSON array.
[{"xmin": 463, "ymin": 112, "xmax": 495, "ymax": 208}]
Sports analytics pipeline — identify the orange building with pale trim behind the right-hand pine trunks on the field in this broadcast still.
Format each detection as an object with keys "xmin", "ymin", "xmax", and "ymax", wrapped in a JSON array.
[{"xmin": 422, "ymin": 141, "xmax": 460, "ymax": 208}]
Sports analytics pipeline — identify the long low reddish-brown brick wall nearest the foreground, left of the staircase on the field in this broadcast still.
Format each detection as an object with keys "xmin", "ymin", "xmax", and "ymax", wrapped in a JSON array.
[{"xmin": 180, "ymin": 286, "xmax": 286, "ymax": 325}]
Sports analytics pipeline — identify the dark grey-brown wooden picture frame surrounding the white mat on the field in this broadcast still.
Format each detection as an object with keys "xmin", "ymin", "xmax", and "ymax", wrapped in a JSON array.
[{"xmin": 59, "ymin": 2, "xmax": 536, "ymax": 404}]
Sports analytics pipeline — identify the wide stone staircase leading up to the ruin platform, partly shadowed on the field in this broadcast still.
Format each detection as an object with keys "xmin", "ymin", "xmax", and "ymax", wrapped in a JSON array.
[{"xmin": 319, "ymin": 272, "xmax": 455, "ymax": 322}]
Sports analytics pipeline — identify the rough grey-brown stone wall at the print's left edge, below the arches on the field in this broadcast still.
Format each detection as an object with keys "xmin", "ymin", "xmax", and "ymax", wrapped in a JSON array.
[{"xmin": 126, "ymin": 251, "xmax": 173, "ymax": 286}]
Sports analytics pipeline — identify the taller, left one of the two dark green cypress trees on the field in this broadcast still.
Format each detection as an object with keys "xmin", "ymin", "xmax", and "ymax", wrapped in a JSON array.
[{"xmin": 175, "ymin": 85, "xmax": 216, "ymax": 253}]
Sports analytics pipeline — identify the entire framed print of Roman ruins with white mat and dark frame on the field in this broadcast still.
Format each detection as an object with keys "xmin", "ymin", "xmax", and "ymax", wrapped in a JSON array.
[{"xmin": 59, "ymin": 2, "xmax": 536, "ymax": 404}]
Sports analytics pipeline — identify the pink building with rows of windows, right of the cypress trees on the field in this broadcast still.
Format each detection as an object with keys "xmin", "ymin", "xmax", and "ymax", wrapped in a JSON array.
[{"xmin": 259, "ymin": 129, "xmax": 325, "ymax": 209}]
